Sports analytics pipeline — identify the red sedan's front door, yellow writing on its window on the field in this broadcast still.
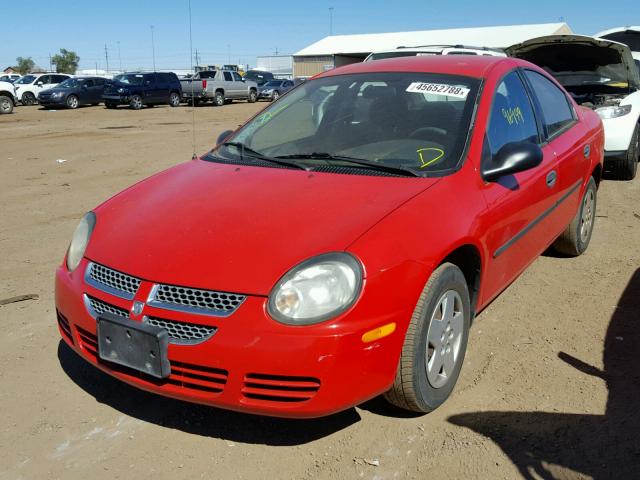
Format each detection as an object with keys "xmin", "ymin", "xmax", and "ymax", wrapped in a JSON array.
[{"xmin": 481, "ymin": 70, "xmax": 560, "ymax": 303}]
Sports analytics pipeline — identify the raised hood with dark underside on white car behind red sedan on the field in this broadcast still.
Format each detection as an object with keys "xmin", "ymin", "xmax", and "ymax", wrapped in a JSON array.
[{"xmin": 505, "ymin": 35, "xmax": 640, "ymax": 89}]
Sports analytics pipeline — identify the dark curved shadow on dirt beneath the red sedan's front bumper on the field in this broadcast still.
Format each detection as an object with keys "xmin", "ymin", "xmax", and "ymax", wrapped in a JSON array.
[{"xmin": 58, "ymin": 340, "xmax": 360, "ymax": 446}]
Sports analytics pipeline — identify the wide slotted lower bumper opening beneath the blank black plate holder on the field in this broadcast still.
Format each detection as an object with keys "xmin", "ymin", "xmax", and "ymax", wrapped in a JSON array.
[{"xmin": 76, "ymin": 327, "xmax": 229, "ymax": 394}]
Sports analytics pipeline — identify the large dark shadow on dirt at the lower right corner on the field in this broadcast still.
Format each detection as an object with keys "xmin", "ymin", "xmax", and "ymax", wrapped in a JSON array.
[{"xmin": 448, "ymin": 269, "xmax": 640, "ymax": 479}]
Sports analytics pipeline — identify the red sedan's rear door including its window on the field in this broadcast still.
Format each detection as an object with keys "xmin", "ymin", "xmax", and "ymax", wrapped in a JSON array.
[{"xmin": 523, "ymin": 69, "xmax": 595, "ymax": 235}]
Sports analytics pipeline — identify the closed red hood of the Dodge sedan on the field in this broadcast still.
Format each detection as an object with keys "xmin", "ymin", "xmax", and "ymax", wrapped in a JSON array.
[{"xmin": 86, "ymin": 160, "xmax": 439, "ymax": 295}]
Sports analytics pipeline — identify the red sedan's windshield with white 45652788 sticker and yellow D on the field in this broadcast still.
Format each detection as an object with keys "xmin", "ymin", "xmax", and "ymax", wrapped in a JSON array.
[{"xmin": 214, "ymin": 72, "xmax": 480, "ymax": 174}]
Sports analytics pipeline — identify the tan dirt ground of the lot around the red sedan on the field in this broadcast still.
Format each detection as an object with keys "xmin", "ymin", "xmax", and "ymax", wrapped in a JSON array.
[{"xmin": 0, "ymin": 103, "xmax": 640, "ymax": 480}]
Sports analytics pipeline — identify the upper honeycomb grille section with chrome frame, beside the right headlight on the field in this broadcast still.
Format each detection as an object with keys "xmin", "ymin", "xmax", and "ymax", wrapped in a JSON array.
[{"xmin": 149, "ymin": 285, "xmax": 246, "ymax": 316}]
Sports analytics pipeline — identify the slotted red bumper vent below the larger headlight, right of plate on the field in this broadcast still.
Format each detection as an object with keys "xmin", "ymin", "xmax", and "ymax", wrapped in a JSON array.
[{"xmin": 242, "ymin": 373, "xmax": 320, "ymax": 403}]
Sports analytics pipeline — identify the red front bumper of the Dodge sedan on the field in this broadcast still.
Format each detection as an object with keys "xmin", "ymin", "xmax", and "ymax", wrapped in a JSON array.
[{"xmin": 56, "ymin": 259, "xmax": 412, "ymax": 418}]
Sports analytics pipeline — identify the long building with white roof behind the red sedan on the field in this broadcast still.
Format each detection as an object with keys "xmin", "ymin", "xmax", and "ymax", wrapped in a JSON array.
[{"xmin": 293, "ymin": 23, "xmax": 573, "ymax": 76}]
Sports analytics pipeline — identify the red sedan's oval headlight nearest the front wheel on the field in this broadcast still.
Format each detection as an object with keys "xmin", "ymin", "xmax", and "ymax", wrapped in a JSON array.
[{"xmin": 268, "ymin": 253, "xmax": 362, "ymax": 325}]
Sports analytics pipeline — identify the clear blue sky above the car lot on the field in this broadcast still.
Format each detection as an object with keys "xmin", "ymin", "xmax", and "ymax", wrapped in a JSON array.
[{"xmin": 0, "ymin": 0, "xmax": 640, "ymax": 70}]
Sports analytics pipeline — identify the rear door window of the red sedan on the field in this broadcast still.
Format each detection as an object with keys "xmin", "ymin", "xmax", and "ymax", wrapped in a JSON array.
[{"xmin": 524, "ymin": 70, "xmax": 575, "ymax": 137}]
